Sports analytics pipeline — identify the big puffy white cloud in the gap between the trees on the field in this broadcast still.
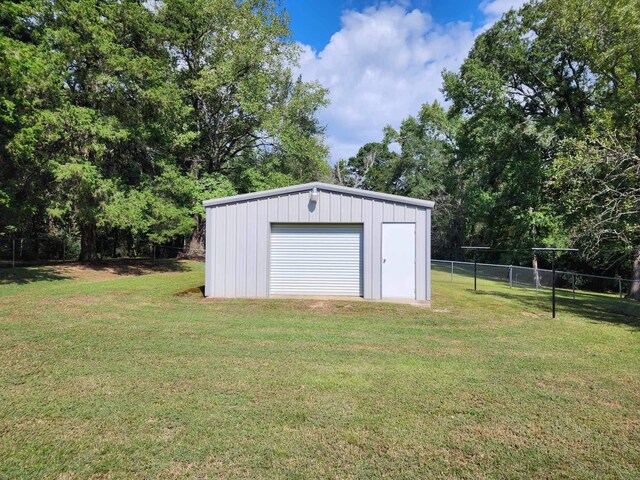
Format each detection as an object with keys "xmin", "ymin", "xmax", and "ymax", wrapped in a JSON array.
[{"xmin": 300, "ymin": 0, "xmax": 522, "ymax": 161}]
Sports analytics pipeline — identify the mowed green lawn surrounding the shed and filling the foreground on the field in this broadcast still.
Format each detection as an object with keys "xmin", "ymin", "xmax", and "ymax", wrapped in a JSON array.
[{"xmin": 0, "ymin": 262, "xmax": 640, "ymax": 479}]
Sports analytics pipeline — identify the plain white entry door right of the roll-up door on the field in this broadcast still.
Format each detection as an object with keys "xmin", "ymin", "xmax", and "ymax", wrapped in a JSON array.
[{"xmin": 382, "ymin": 223, "xmax": 416, "ymax": 298}]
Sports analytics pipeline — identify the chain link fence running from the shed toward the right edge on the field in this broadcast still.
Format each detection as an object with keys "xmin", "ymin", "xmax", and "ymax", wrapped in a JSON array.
[{"xmin": 431, "ymin": 260, "xmax": 640, "ymax": 317}]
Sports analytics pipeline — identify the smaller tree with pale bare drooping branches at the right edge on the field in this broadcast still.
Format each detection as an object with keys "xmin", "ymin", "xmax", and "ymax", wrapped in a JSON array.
[{"xmin": 553, "ymin": 133, "xmax": 640, "ymax": 300}]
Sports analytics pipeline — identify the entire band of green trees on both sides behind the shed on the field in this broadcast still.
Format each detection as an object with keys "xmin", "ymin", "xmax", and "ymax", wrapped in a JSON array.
[{"xmin": 0, "ymin": 0, "xmax": 640, "ymax": 298}]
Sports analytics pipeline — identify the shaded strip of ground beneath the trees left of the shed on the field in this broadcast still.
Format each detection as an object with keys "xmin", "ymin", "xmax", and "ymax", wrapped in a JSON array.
[{"xmin": 0, "ymin": 259, "xmax": 190, "ymax": 285}]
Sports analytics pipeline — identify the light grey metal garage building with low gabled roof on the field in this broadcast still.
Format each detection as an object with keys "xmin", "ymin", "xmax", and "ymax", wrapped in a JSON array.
[{"xmin": 203, "ymin": 182, "xmax": 433, "ymax": 300}]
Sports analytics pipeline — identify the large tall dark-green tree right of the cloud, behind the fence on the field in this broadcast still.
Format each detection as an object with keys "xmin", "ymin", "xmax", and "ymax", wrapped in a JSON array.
[{"xmin": 444, "ymin": 0, "xmax": 640, "ymax": 282}]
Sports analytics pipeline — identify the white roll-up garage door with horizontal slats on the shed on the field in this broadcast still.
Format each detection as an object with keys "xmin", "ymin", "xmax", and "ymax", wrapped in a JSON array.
[{"xmin": 270, "ymin": 224, "xmax": 362, "ymax": 296}]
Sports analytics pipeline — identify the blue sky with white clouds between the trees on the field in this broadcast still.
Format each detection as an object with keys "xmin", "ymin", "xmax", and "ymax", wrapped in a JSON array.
[{"xmin": 283, "ymin": 0, "xmax": 524, "ymax": 163}]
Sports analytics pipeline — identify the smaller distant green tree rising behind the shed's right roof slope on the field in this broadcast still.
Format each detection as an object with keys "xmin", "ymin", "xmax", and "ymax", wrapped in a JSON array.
[{"xmin": 334, "ymin": 102, "xmax": 466, "ymax": 256}]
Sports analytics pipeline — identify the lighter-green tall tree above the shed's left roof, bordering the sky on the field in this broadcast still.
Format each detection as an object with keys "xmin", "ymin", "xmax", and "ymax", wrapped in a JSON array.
[{"xmin": 158, "ymin": 0, "xmax": 328, "ymax": 250}]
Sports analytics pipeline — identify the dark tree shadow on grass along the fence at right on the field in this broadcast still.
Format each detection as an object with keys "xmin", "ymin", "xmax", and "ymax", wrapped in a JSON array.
[{"xmin": 477, "ymin": 290, "xmax": 640, "ymax": 329}]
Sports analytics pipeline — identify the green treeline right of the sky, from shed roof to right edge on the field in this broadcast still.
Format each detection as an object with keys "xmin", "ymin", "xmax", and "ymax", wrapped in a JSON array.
[{"xmin": 334, "ymin": 0, "xmax": 640, "ymax": 298}]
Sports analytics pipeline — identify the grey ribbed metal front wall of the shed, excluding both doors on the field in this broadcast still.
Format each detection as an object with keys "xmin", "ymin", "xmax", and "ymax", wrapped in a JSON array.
[{"xmin": 205, "ymin": 190, "xmax": 431, "ymax": 300}]
